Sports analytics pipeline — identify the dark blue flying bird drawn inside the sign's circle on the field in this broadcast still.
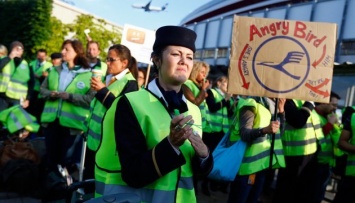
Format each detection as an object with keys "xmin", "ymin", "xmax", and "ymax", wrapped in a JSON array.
[{"xmin": 257, "ymin": 51, "xmax": 304, "ymax": 80}]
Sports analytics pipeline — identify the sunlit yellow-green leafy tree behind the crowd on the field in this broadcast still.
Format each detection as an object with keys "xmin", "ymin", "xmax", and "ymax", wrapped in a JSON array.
[{"xmin": 68, "ymin": 14, "xmax": 121, "ymax": 59}]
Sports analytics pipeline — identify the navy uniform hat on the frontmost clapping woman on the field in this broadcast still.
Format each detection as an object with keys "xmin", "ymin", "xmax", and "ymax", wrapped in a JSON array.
[{"xmin": 153, "ymin": 26, "xmax": 197, "ymax": 53}]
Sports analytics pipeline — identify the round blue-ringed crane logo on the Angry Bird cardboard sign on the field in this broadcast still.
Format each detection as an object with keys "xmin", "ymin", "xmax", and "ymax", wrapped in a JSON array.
[{"xmin": 252, "ymin": 36, "xmax": 310, "ymax": 94}]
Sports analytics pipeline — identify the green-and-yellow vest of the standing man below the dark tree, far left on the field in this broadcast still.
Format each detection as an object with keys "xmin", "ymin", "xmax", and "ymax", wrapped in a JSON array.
[{"xmin": 6, "ymin": 60, "xmax": 30, "ymax": 99}]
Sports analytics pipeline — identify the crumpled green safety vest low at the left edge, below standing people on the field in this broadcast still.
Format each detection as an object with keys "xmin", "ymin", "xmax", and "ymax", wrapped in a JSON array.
[{"xmin": 0, "ymin": 105, "xmax": 39, "ymax": 134}]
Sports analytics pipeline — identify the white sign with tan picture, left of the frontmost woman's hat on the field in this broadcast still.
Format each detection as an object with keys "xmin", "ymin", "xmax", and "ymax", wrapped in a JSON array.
[{"xmin": 121, "ymin": 24, "xmax": 155, "ymax": 64}]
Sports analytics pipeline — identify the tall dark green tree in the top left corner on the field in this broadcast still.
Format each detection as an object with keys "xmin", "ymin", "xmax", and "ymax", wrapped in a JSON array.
[{"xmin": 0, "ymin": 0, "xmax": 53, "ymax": 59}]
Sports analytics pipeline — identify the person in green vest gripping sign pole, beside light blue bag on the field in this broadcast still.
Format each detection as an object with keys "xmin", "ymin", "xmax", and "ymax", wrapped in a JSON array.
[{"xmin": 228, "ymin": 97, "xmax": 286, "ymax": 203}]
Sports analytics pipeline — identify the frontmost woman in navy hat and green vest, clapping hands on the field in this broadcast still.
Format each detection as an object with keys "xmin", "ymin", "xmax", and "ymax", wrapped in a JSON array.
[{"xmin": 95, "ymin": 26, "xmax": 213, "ymax": 203}]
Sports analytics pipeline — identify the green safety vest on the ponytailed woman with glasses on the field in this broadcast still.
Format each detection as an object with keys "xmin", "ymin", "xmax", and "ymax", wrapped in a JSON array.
[{"xmin": 87, "ymin": 73, "xmax": 135, "ymax": 151}]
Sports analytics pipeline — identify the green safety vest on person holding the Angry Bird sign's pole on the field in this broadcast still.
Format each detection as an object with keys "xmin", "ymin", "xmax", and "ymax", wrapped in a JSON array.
[{"xmin": 231, "ymin": 98, "xmax": 285, "ymax": 175}]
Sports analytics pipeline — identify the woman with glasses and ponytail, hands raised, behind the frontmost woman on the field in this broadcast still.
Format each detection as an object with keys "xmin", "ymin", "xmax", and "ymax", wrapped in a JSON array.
[{"xmin": 84, "ymin": 44, "xmax": 138, "ymax": 186}]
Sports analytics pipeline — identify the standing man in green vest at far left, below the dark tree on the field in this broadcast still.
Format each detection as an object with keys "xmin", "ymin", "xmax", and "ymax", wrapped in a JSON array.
[{"xmin": 0, "ymin": 41, "xmax": 34, "ymax": 112}]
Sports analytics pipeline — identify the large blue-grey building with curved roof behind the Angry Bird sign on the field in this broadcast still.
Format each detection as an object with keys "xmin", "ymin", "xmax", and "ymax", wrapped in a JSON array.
[{"xmin": 180, "ymin": 0, "xmax": 355, "ymax": 106}]
